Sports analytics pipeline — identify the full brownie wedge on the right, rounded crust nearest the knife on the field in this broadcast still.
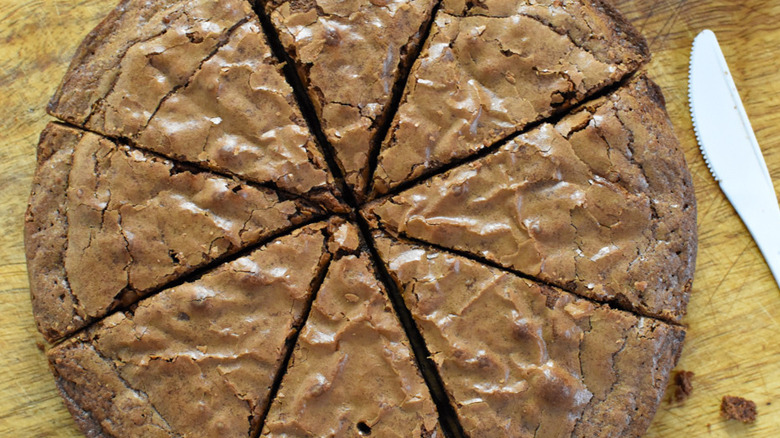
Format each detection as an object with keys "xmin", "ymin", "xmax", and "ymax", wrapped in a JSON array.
[{"xmin": 367, "ymin": 77, "xmax": 696, "ymax": 321}]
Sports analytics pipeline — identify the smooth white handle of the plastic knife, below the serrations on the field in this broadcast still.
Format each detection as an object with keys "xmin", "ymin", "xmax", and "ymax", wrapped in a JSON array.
[{"xmin": 721, "ymin": 183, "xmax": 780, "ymax": 285}]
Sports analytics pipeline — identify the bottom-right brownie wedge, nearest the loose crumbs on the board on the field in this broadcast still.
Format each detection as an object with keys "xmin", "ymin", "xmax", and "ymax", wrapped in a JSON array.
[{"xmin": 375, "ymin": 232, "xmax": 685, "ymax": 438}]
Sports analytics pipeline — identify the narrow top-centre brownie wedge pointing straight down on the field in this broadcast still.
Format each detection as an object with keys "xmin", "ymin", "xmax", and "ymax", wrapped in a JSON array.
[{"xmin": 265, "ymin": 0, "xmax": 436, "ymax": 196}]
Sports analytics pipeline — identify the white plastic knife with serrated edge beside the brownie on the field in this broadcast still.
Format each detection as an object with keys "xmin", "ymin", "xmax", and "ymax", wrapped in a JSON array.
[{"xmin": 688, "ymin": 30, "xmax": 780, "ymax": 285}]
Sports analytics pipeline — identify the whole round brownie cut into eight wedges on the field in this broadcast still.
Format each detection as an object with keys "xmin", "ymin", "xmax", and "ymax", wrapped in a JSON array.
[{"xmin": 25, "ymin": 0, "xmax": 697, "ymax": 438}]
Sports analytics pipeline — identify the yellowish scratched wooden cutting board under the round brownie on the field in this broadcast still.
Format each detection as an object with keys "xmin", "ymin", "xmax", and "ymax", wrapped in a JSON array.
[{"xmin": 0, "ymin": 0, "xmax": 780, "ymax": 437}]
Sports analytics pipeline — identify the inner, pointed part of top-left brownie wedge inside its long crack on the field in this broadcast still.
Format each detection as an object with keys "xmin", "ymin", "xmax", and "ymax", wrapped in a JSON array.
[{"xmin": 136, "ymin": 20, "xmax": 329, "ymax": 194}]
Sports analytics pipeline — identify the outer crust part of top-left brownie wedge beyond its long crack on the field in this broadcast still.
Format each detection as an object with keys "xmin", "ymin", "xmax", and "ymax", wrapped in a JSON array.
[{"xmin": 49, "ymin": 0, "xmax": 251, "ymax": 126}]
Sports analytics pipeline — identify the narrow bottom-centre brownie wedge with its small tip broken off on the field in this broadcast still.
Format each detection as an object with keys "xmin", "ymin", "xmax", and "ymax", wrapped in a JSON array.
[{"xmin": 263, "ymin": 223, "xmax": 443, "ymax": 438}]
